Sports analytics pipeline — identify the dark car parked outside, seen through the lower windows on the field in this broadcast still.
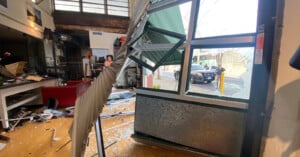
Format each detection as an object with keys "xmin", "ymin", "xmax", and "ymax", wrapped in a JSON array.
[{"xmin": 174, "ymin": 64, "xmax": 215, "ymax": 84}]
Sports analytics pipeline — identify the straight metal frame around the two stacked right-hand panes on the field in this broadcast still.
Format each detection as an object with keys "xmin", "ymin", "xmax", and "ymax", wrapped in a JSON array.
[{"xmin": 185, "ymin": 1, "xmax": 257, "ymax": 102}]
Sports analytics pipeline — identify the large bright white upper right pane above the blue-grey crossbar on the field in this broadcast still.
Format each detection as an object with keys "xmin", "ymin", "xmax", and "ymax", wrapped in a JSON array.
[{"xmin": 195, "ymin": 0, "xmax": 258, "ymax": 38}]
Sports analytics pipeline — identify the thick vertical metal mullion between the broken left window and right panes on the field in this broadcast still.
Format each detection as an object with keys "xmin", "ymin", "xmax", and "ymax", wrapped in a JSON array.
[{"xmin": 179, "ymin": 0, "xmax": 197, "ymax": 95}]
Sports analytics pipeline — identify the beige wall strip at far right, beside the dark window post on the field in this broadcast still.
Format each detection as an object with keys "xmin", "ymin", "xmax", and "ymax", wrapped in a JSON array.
[{"xmin": 263, "ymin": 0, "xmax": 300, "ymax": 157}]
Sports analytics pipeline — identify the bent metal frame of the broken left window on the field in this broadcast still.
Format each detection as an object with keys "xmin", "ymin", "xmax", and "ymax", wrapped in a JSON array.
[{"xmin": 128, "ymin": 0, "xmax": 191, "ymax": 94}]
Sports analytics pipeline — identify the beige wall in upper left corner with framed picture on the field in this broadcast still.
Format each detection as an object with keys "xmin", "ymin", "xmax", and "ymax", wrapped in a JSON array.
[{"xmin": 0, "ymin": 0, "xmax": 55, "ymax": 38}]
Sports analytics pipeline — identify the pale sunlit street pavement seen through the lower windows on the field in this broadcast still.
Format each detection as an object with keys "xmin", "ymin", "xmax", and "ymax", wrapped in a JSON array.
[{"xmin": 154, "ymin": 71, "xmax": 250, "ymax": 99}]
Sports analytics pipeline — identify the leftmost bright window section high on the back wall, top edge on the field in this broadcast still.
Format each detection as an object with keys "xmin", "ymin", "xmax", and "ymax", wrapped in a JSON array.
[{"xmin": 55, "ymin": 0, "xmax": 80, "ymax": 12}]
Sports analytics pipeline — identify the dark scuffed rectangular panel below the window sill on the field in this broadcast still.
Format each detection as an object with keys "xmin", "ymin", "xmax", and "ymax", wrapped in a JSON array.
[{"xmin": 134, "ymin": 95, "xmax": 245, "ymax": 156}]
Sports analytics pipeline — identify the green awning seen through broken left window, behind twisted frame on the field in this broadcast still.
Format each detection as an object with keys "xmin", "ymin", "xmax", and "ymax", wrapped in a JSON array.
[{"xmin": 129, "ymin": 1, "xmax": 185, "ymax": 71}]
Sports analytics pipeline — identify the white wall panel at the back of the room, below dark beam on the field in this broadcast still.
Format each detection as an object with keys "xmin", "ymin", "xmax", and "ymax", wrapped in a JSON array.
[{"xmin": 89, "ymin": 30, "xmax": 125, "ymax": 54}]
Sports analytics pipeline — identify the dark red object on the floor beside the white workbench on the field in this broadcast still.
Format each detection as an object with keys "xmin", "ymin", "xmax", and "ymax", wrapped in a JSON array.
[{"xmin": 42, "ymin": 80, "xmax": 91, "ymax": 107}]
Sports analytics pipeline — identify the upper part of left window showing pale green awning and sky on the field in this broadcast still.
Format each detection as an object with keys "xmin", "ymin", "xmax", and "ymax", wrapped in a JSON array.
[{"xmin": 148, "ymin": 2, "xmax": 192, "ymax": 35}]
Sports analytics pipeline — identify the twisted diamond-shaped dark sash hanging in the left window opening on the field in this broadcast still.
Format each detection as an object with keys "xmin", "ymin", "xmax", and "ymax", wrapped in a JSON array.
[{"xmin": 129, "ymin": 26, "xmax": 184, "ymax": 71}]
